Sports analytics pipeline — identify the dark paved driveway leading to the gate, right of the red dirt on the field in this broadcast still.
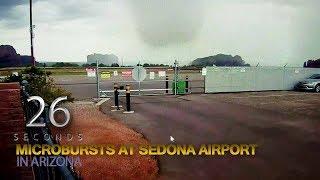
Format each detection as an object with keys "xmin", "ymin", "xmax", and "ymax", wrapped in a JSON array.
[{"xmin": 102, "ymin": 95, "xmax": 320, "ymax": 179}]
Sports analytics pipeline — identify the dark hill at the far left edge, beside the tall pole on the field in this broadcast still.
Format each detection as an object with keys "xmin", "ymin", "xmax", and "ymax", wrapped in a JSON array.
[{"xmin": 0, "ymin": 45, "xmax": 32, "ymax": 68}]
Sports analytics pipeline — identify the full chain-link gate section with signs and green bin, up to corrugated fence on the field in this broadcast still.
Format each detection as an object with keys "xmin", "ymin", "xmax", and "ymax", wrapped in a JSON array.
[{"xmin": 96, "ymin": 61, "xmax": 204, "ymax": 98}]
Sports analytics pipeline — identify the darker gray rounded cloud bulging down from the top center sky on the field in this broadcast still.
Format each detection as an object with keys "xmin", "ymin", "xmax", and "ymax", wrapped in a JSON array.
[{"xmin": 129, "ymin": 0, "xmax": 204, "ymax": 46}]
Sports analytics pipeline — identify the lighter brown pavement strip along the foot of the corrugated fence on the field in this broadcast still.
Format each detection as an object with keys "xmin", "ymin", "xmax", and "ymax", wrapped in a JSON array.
[{"xmin": 181, "ymin": 91, "xmax": 320, "ymax": 119}]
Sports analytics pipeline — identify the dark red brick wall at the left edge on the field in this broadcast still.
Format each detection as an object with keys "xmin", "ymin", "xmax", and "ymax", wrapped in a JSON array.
[{"xmin": 0, "ymin": 83, "xmax": 33, "ymax": 179}]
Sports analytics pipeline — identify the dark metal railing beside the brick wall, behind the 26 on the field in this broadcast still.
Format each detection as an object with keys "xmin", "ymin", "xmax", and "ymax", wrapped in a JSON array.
[{"xmin": 21, "ymin": 82, "xmax": 81, "ymax": 180}]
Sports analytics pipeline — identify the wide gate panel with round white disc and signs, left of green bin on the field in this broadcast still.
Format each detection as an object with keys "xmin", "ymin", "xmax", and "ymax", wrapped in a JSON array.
[{"xmin": 96, "ymin": 63, "xmax": 174, "ymax": 97}]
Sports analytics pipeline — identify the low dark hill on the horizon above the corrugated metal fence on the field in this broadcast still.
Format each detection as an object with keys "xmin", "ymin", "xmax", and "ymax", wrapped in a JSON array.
[{"xmin": 191, "ymin": 54, "xmax": 250, "ymax": 67}]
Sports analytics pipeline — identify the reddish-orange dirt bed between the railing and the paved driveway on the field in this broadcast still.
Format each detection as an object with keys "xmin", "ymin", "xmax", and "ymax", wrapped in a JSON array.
[{"xmin": 52, "ymin": 104, "xmax": 159, "ymax": 179}]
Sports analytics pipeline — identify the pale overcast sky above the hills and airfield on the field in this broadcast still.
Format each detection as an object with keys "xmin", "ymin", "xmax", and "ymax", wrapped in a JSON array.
[{"xmin": 0, "ymin": 0, "xmax": 320, "ymax": 66}]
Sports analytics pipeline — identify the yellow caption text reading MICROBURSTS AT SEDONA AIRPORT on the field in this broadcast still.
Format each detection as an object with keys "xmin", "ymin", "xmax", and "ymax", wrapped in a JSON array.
[{"xmin": 16, "ymin": 144, "xmax": 258, "ymax": 156}]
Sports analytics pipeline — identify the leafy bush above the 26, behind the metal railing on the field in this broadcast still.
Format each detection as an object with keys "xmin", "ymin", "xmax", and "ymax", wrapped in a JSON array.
[{"xmin": 4, "ymin": 67, "xmax": 74, "ymax": 104}]
